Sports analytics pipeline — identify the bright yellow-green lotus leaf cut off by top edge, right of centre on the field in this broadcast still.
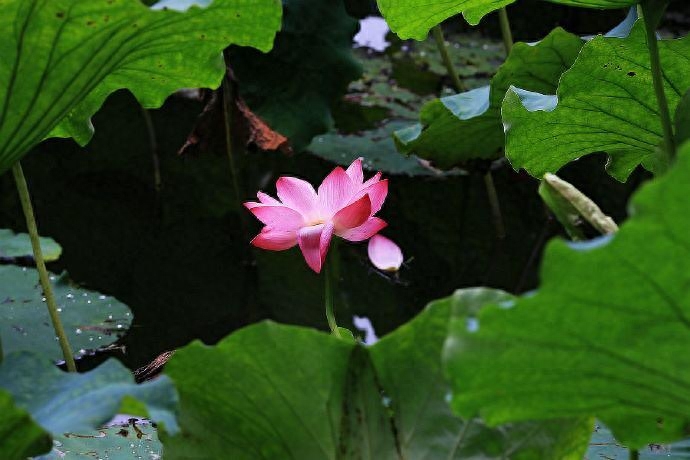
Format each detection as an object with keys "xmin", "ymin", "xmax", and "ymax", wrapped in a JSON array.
[{"xmin": 377, "ymin": 0, "xmax": 515, "ymax": 41}]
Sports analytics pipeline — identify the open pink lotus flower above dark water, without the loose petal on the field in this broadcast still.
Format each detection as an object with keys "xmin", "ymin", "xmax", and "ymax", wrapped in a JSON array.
[{"xmin": 244, "ymin": 159, "xmax": 388, "ymax": 273}]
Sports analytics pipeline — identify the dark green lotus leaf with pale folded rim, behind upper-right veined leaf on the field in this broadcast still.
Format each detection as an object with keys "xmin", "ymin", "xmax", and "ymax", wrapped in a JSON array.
[{"xmin": 394, "ymin": 28, "xmax": 584, "ymax": 168}]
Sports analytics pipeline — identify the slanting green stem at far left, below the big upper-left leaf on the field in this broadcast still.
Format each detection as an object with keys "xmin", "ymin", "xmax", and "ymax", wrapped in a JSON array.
[{"xmin": 12, "ymin": 162, "xmax": 77, "ymax": 372}]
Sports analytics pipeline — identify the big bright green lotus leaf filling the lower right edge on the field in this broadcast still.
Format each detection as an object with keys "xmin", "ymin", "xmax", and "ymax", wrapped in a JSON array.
[{"xmin": 446, "ymin": 143, "xmax": 690, "ymax": 447}]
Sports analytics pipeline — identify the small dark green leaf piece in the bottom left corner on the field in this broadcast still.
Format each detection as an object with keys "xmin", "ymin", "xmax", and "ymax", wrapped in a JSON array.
[{"xmin": 0, "ymin": 390, "xmax": 52, "ymax": 460}]
